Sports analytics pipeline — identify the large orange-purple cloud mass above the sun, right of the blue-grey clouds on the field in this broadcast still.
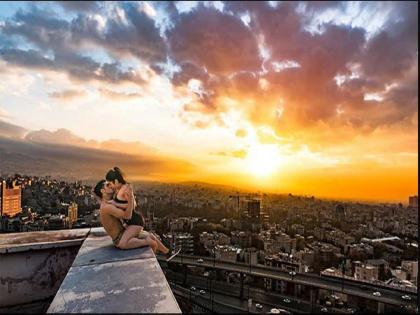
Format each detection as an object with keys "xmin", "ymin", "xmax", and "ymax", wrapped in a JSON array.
[{"xmin": 168, "ymin": 1, "xmax": 418, "ymax": 131}]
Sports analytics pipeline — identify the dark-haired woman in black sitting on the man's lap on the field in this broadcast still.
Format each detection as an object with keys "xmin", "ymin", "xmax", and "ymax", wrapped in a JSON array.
[{"xmin": 105, "ymin": 167, "xmax": 169, "ymax": 254}]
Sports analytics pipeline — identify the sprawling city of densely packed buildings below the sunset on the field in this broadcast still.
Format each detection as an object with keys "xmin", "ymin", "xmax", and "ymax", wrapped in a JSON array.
[{"xmin": 1, "ymin": 174, "xmax": 419, "ymax": 314}]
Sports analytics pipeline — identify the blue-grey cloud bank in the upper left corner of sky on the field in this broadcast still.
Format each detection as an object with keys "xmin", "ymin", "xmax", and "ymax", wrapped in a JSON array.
[{"xmin": 0, "ymin": 3, "xmax": 166, "ymax": 63}]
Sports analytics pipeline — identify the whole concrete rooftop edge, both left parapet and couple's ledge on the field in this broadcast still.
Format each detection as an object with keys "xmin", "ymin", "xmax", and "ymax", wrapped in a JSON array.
[{"xmin": 0, "ymin": 228, "xmax": 181, "ymax": 313}]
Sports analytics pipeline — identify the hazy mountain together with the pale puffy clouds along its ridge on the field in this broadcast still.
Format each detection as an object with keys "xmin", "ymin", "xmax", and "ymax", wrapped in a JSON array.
[{"xmin": 0, "ymin": 120, "xmax": 195, "ymax": 180}]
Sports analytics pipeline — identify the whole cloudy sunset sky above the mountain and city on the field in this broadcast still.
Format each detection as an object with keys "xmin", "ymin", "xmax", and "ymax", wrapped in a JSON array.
[{"xmin": 0, "ymin": 1, "xmax": 418, "ymax": 203}]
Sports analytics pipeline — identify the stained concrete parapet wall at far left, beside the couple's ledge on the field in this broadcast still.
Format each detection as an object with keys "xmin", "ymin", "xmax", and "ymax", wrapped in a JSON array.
[{"xmin": 0, "ymin": 229, "xmax": 90, "ymax": 312}]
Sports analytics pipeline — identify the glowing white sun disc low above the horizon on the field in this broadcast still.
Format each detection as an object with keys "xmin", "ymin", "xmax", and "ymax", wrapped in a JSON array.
[{"xmin": 245, "ymin": 144, "xmax": 281, "ymax": 177}]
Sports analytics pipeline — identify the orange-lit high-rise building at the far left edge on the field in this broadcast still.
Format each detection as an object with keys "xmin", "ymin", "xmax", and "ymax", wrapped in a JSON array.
[{"xmin": 0, "ymin": 179, "xmax": 22, "ymax": 217}]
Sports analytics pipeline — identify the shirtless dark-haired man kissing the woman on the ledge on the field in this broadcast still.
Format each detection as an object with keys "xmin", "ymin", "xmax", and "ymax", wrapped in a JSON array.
[{"xmin": 93, "ymin": 180, "xmax": 158, "ymax": 253}]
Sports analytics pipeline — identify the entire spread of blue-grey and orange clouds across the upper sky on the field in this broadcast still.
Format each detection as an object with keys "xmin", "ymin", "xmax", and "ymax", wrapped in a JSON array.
[{"xmin": 0, "ymin": 1, "xmax": 418, "ymax": 135}]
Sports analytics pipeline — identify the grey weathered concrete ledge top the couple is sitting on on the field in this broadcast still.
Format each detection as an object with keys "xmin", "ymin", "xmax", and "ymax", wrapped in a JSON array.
[{"xmin": 47, "ymin": 228, "xmax": 181, "ymax": 314}]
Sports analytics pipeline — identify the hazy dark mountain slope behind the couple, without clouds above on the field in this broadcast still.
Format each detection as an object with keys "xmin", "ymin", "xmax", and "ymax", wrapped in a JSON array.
[{"xmin": 0, "ymin": 133, "xmax": 195, "ymax": 180}]
